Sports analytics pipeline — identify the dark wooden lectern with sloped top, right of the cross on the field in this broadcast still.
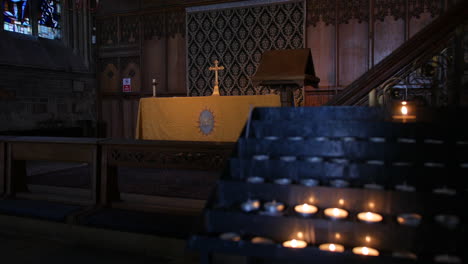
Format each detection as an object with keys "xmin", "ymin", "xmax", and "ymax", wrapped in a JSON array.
[{"xmin": 252, "ymin": 49, "xmax": 320, "ymax": 106}]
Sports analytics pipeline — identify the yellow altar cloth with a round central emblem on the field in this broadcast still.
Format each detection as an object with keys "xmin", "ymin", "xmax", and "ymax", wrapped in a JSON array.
[{"xmin": 136, "ymin": 94, "xmax": 281, "ymax": 142}]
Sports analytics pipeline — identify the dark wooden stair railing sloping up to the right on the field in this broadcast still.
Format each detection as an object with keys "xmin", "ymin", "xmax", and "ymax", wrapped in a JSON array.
[{"xmin": 327, "ymin": 1, "xmax": 468, "ymax": 105}]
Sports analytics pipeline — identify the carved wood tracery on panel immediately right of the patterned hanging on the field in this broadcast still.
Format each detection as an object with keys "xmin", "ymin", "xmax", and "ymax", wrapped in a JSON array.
[{"xmin": 307, "ymin": 0, "xmax": 336, "ymax": 27}]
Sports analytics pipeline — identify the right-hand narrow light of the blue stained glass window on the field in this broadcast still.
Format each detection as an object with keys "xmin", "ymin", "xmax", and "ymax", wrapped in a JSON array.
[{"xmin": 38, "ymin": 0, "xmax": 62, "ymax": 39}]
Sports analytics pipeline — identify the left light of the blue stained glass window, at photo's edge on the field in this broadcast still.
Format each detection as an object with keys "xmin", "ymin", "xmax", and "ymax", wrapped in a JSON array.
[{"xmin": 2, "ymin": 0, "xmax": 32, "ymax": 35}]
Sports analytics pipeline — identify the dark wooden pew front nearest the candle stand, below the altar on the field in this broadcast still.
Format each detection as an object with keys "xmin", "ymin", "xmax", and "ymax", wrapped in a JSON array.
[{"xmin": 99, "ymin": 140, "xmax": 234, "ymax": 213}]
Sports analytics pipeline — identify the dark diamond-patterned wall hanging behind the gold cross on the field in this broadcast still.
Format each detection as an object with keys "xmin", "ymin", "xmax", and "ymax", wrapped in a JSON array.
[{"xmin": 187, "ymin": 1, "xmax": 305, "ymax": 101}]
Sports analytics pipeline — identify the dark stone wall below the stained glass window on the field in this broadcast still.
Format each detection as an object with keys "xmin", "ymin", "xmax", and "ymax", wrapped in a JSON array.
[{"xmin": 0, "ymin": 5, "xmax": 97, "ymax": 136}]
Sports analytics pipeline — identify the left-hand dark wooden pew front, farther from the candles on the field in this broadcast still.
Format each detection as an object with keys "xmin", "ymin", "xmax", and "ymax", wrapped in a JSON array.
[{"xmin": 6, "ymin": 137, "xmax": 102, "ymax": 206}]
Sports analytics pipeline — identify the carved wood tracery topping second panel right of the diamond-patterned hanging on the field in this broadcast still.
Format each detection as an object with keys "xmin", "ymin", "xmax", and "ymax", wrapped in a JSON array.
[{"xmin": 337, "ymin": 0, "xmax": 369, "ymax": 24}]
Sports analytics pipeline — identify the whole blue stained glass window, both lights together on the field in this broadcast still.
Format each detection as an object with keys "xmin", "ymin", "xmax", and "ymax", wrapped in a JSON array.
[{"xmin": 0, "ymin": 0, "xmax": 62, "ymax": 39}]
